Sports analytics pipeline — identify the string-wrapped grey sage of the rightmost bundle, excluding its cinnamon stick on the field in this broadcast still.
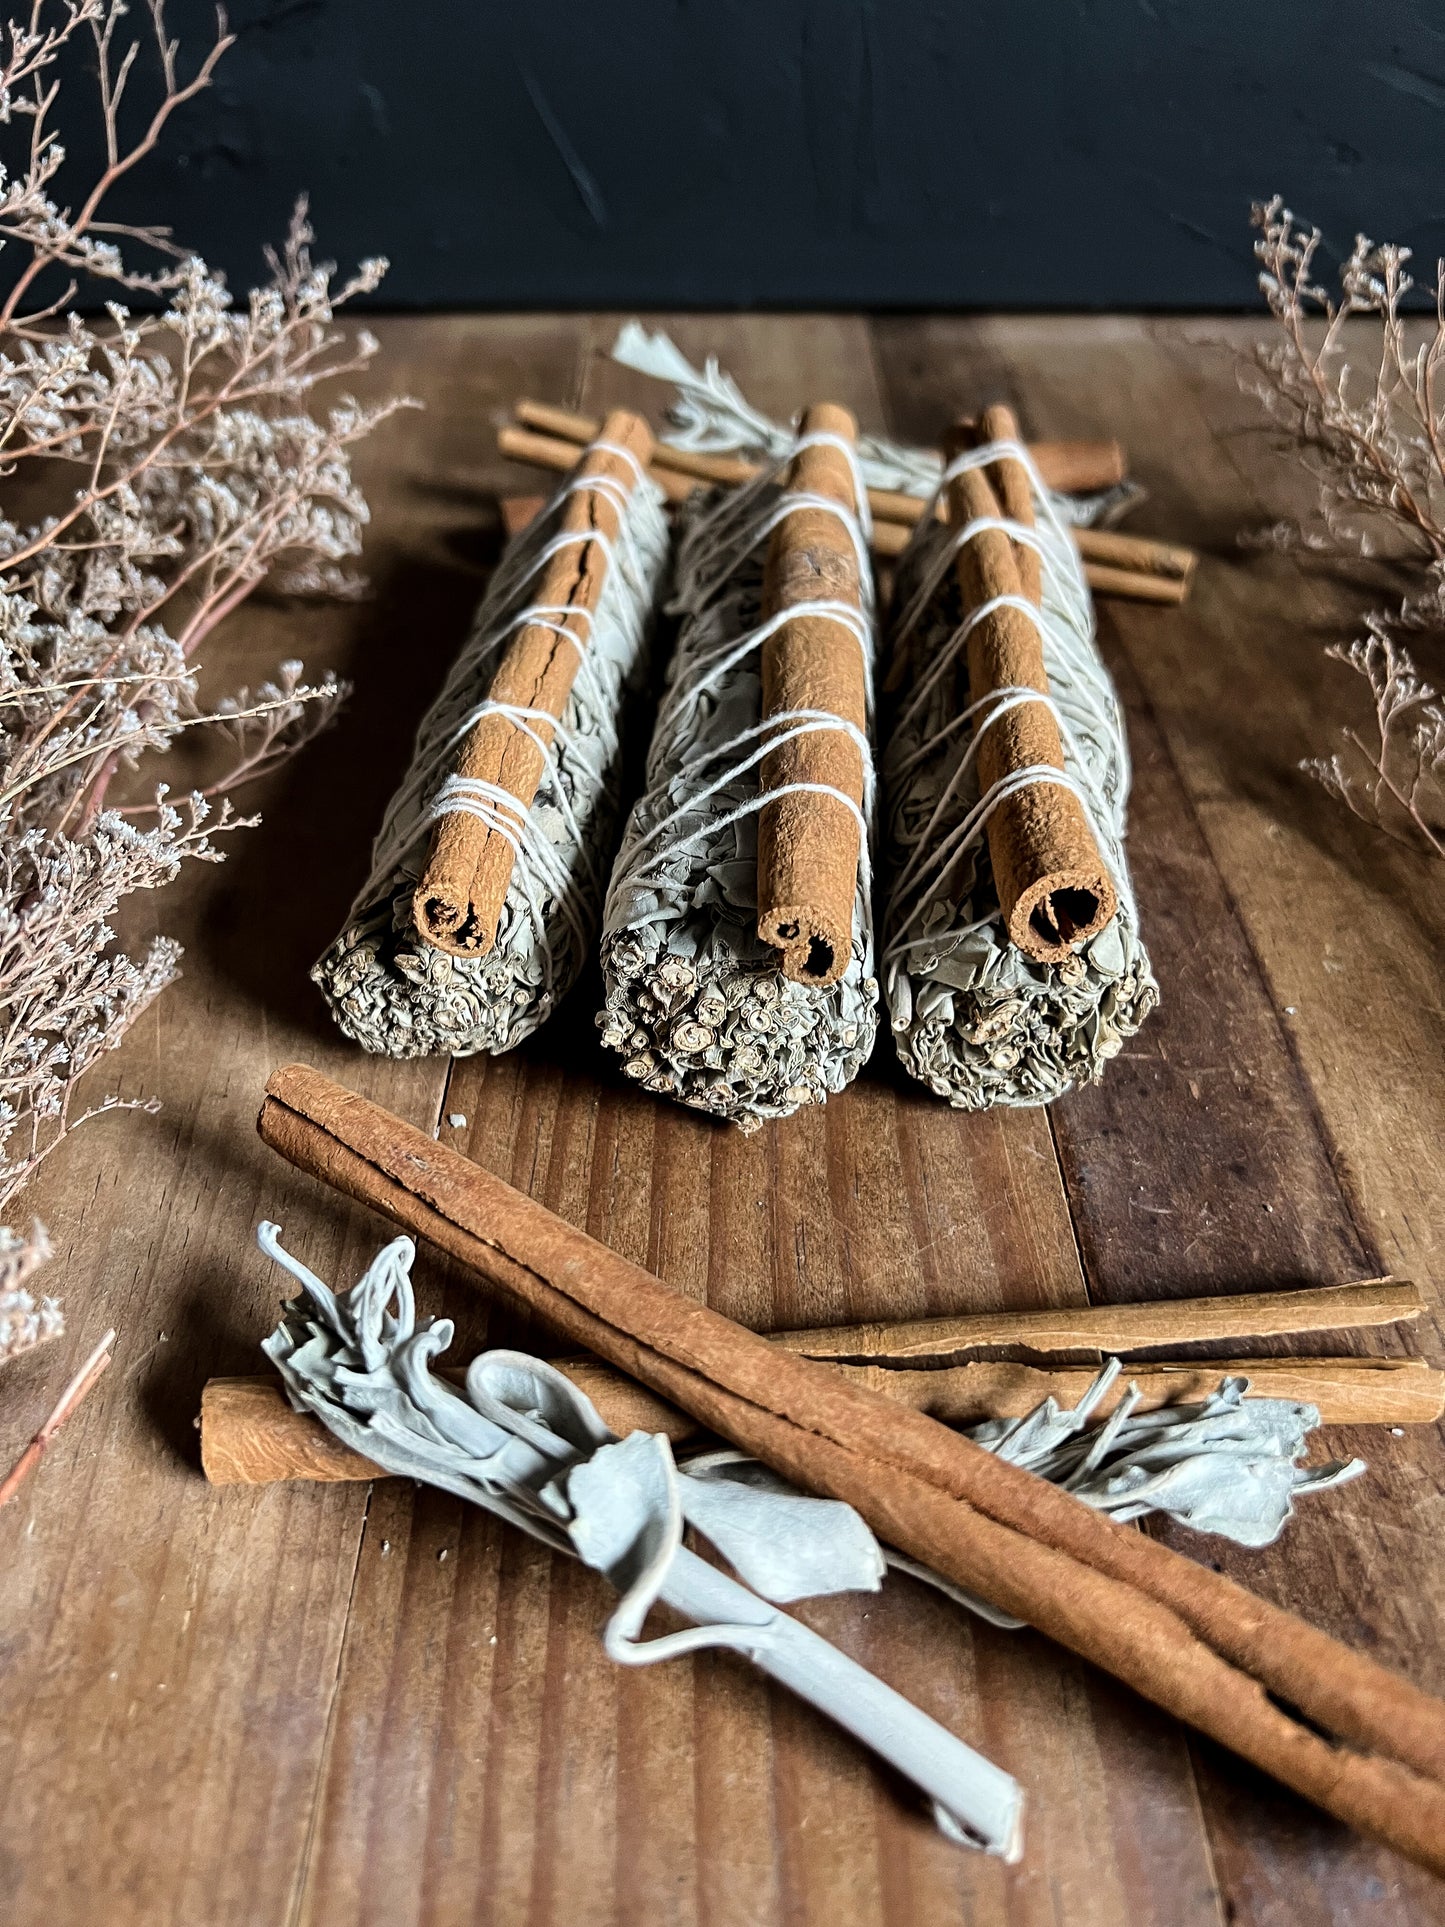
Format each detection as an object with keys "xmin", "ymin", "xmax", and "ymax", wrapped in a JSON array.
[{"xmin": 882, "ymin": 441, "xmax": 1158, "ymax": 1110}]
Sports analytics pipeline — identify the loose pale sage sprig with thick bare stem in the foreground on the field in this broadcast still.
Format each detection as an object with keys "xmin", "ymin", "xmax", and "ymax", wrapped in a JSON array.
[{"xmin": 258, "ymin": 1224, "xmax": 1023, "ymax": 1860}]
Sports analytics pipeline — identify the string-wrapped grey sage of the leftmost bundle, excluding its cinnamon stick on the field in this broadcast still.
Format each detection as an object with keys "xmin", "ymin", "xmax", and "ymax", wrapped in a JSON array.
[{"xmin": 312, "ymin": 466, "xmax": 669, "ymax": 1058}]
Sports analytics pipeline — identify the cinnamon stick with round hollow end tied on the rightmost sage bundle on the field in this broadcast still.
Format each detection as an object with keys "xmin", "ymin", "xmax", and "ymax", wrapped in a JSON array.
[{"xmin": 948, "ymin": 409, "xmax": 1117, "ymax": 964}]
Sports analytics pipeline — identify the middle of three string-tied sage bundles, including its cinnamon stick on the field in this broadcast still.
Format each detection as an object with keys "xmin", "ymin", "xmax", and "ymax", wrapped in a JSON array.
[{"xmin": 597, "ymin": 407, "xmax": 877, "ymax": 1127}]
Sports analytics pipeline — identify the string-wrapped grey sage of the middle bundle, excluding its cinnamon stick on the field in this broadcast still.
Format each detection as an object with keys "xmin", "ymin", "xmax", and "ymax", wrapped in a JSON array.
[{"xmin": 597, "ymin": 434, "xmax": 879, "ymax": 1129}]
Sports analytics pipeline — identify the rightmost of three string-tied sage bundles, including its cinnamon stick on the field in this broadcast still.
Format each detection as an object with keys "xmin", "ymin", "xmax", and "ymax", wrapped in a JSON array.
[{"xmin": 882, "ymin": 409, "xmax": 1158, "ymax": 1110}]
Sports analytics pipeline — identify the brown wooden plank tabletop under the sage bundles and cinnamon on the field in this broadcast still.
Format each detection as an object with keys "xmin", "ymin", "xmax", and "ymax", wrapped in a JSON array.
[{"xmin": 0, "ymin": 316, "xmax": 1445, "ymax": 1927}]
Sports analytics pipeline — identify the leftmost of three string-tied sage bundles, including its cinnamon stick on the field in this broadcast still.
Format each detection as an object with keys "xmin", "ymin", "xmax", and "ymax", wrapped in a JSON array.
[{"xmin": 312, "ymin": 410, "xmax": 669, "ymax": 1058}]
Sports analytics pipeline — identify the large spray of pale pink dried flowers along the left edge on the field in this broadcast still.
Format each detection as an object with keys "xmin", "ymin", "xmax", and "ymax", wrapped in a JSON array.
[{"xmin": 0, "ymin": 0, "xmax": 408, "ymax": 1357}]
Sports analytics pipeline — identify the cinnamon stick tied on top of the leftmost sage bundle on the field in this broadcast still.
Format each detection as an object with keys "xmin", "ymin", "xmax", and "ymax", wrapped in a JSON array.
[{"xmin": 412, "ymin": 409, "xmax": 653, "ymax": 956}]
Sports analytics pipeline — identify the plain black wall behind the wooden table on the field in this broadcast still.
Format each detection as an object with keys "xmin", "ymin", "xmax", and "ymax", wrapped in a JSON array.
[{"xmin": 36, "ymin": 0, "xmax": 1445, "ymax": 308}]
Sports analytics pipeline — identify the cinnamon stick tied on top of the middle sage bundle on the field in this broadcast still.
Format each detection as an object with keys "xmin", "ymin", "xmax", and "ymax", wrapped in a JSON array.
[{"xmin": 757, "ymin": 403, "xmax": 867, "ymax": 989}]
